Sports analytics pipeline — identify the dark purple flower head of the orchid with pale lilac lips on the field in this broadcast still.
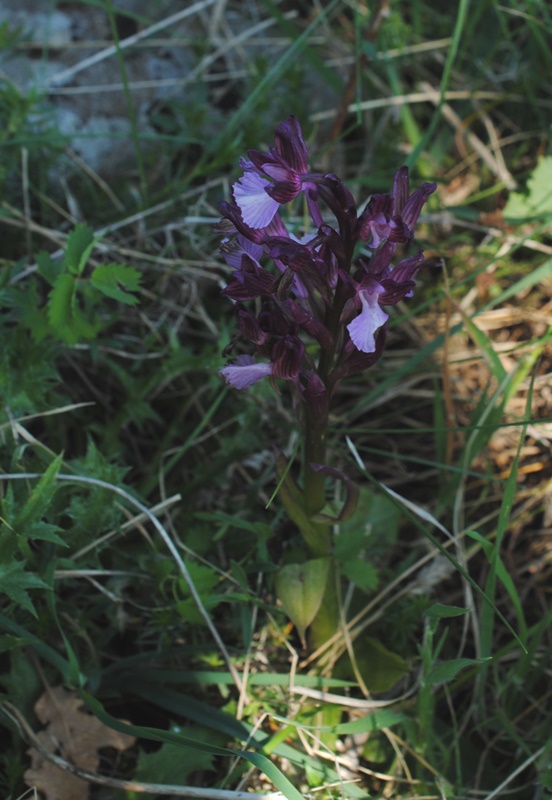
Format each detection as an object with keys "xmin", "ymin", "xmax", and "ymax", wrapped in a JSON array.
[{"xmin": 219, "ymin": 116, "xmax": 438, "ymax": 392}]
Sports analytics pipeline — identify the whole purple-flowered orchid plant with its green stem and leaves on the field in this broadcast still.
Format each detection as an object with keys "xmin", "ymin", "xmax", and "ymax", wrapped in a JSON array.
[{"xmin": 218, "ymin": 116, "xmax": 437, "ymax": 647}]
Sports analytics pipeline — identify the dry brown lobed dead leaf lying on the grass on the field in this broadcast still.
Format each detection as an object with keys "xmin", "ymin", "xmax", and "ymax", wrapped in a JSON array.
[{"xmin": 24, "ymin": 686, "xmax": 136, "ymax": 800}]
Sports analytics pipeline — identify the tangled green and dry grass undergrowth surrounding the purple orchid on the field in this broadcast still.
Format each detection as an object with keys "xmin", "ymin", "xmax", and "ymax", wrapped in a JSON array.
[{"xmin": 0, "ymin": 0, "xmax": 552, "ymax": 800}]
